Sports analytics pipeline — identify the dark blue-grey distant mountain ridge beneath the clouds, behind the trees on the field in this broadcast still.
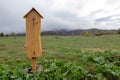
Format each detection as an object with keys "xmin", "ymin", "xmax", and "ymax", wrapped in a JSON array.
[{"xmin": 17, "ymin": 28, "xmax": 117, "ymax": 36}]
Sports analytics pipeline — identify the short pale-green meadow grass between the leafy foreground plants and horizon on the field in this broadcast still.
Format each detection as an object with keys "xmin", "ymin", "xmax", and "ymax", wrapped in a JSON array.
[{"xmin": 0, "ymin": 36, "xmax": 120, "ymax": 63}]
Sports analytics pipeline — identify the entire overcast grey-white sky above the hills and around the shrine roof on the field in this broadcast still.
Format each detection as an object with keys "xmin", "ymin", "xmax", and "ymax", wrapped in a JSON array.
[{"xmin": 0, "ymin": 0, "xmax": 120, "ymax": 33}]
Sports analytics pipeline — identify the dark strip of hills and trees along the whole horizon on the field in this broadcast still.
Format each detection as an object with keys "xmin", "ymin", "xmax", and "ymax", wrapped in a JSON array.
[{"xmin": 0, "ymin": 29, "xmax": 120, "ymax": 37}]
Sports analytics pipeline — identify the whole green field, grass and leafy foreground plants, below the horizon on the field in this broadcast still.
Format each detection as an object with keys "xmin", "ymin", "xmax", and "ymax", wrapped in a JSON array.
[{"xmin": 0, "ymin": 35, "xmax": 120, "ymax": 80}]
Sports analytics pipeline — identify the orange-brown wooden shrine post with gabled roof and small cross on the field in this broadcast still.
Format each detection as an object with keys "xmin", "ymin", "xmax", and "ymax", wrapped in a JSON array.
[{"xmin": 24, "ymin": 8, "xmax": 43, "ymax": 71}]
